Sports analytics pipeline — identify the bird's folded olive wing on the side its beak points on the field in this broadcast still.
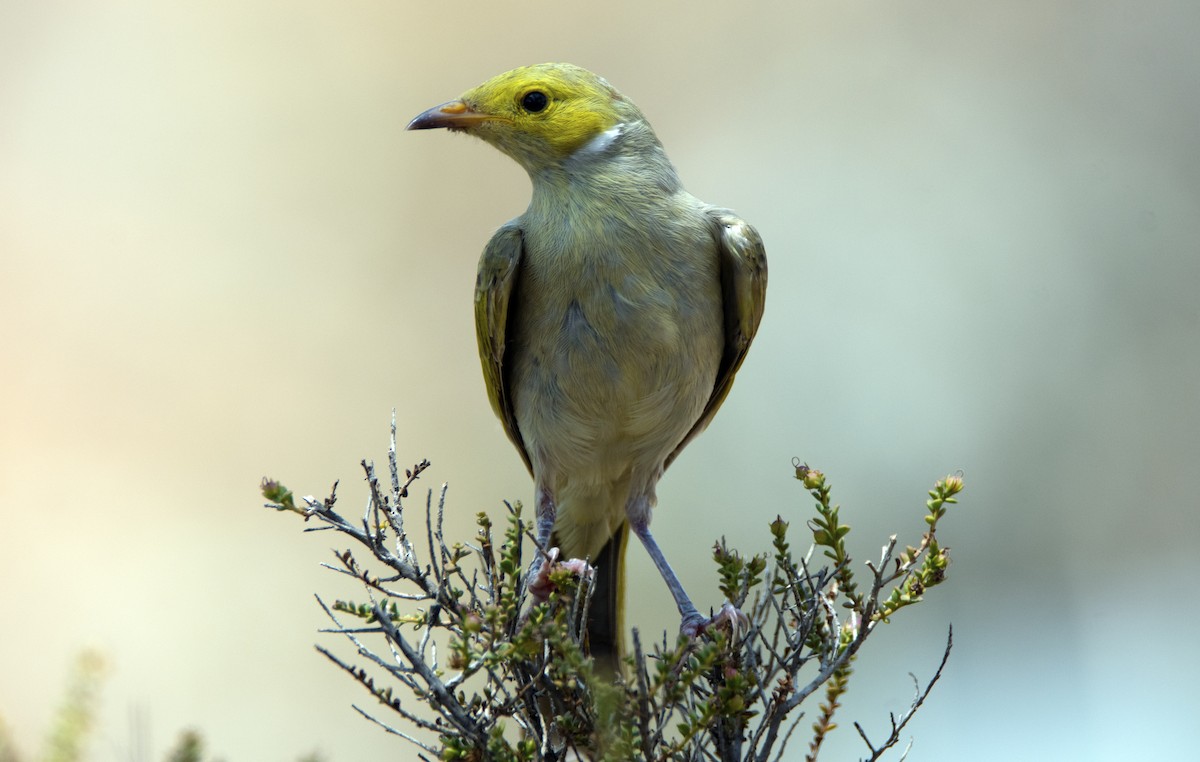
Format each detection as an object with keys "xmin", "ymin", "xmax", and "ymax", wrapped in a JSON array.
[{"xmin": 475, "ymin": 222, "xmax": 533, "ymax": 474}]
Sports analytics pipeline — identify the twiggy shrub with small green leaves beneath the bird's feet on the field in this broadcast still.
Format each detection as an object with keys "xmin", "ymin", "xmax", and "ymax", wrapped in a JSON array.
[{"xmin": 264, "ymin": 434, "xmax": 962, "ymax": 762}]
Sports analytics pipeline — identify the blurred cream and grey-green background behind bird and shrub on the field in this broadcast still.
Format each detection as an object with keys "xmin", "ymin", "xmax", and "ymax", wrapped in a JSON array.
[{"xmin": 0, "ymin": 0, "xmax": 1200, "ymax": 762}]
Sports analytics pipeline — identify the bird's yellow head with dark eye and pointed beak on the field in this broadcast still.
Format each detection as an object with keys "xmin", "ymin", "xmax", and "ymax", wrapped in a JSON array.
[{"xmin": 408, "ymin": 64, "xmax": 653, "ymax": 173}]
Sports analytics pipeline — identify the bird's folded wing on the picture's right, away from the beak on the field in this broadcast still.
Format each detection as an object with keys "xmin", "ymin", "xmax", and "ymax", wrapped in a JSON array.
[{"xmin": 664, "ymin": 209, "xmax": 767, "ymax": 468}]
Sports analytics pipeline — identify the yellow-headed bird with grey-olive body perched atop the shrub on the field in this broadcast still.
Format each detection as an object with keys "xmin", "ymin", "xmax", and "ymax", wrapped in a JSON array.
[{"xmin": 408, "ymin": 64, "xmax": 767, "ymax": 671}]
